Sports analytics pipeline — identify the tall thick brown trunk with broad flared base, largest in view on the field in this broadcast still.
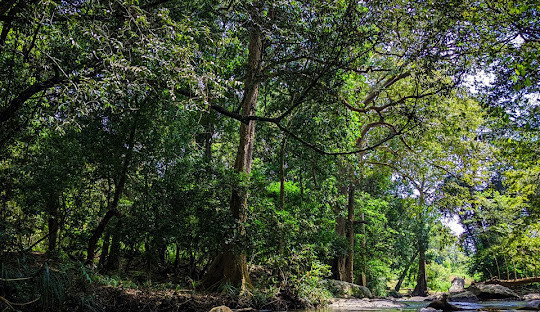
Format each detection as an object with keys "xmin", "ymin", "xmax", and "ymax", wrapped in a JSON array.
[{"xmin": 202, "ymin": 25, "xmax": 262, "ymax": 290}]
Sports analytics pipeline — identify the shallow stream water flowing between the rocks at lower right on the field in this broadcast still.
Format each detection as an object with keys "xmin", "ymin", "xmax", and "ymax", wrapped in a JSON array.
[{"xmin": 305, "ymin": 300, "xmax": 526, "ymax": 312}]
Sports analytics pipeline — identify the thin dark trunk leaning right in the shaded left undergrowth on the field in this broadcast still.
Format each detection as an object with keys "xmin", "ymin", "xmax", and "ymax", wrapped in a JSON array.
[{"xmin": 86, "ymin": 119, "xmax": 137, "ymax": 264}]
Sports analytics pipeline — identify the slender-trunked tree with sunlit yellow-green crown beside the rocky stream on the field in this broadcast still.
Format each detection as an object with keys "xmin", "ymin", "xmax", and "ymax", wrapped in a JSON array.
[{"xmin": 368, "ymin": 95, "xmax": 485, "ymax": 296}]
